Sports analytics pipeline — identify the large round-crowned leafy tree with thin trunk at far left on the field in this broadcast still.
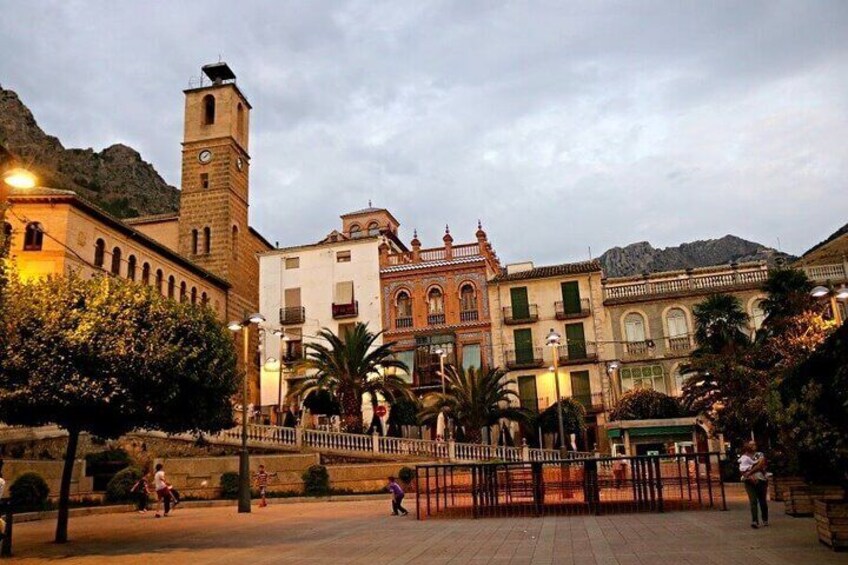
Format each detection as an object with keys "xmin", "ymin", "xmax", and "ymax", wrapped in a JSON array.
[{"xmin": 0, "ymin": 275, "xmax": 239, "ymax": 542}]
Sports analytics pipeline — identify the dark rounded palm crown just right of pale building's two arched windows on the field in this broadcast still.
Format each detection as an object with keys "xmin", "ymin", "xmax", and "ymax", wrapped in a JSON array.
[{"xmin": 693, "ymin": 294, "xmax": 750, "ymax": 354}]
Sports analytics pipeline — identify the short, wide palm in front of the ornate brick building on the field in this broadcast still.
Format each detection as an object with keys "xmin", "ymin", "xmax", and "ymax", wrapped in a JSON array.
[{"xmin": 420, "ymin": 367, "xmax": 529, "ymax": 443}]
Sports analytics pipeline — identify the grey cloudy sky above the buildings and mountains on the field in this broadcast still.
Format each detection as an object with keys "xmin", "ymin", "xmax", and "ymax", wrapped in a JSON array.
[{"xmin": 0, "ymin": 0, "xmax": 848, "ymax": 264}]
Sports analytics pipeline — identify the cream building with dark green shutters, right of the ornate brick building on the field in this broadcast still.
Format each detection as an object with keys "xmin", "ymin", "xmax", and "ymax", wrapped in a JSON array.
[{"xmin": 489, "ymin": 261, "xmax": 607, "ymax": 449}]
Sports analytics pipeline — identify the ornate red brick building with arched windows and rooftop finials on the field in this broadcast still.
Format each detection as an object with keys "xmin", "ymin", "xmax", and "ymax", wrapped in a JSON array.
[{"xmin": 380, "ymin": 225, "xmax": 500, "ymax": 391}]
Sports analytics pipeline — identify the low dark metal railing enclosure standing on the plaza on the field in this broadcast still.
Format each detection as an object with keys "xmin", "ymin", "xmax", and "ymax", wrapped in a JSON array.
[{"xmin": 415, "ymin": 453, "xmax": 727, "ymax": 520}]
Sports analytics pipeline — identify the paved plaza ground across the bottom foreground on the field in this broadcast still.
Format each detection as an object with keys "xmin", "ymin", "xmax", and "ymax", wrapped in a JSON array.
[{"xmin": 3, "ymin": 490, "xmax": 848, "ymax": 565}]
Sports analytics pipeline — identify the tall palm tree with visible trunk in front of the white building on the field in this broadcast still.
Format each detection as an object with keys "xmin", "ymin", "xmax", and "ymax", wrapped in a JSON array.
[{"xmin": 289, "ymin": 322, "xmax": 412, "ymax": 433}]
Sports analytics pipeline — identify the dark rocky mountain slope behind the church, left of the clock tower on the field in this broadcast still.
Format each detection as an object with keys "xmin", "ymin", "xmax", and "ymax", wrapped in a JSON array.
[{"xmin": 0, "ymin": 86, "xmax": 179, "ymax": 218}]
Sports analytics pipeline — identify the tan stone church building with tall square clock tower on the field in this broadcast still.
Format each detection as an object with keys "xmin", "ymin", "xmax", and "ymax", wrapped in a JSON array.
[{"xmin": 6, "ymin": 63, "xmax": 272, "ymax": 399}]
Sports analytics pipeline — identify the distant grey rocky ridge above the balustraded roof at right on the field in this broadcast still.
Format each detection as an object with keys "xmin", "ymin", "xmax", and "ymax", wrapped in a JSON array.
[{"xmin": 599, "ymin": 235, "xmax": 794, "ymax": 277}]
